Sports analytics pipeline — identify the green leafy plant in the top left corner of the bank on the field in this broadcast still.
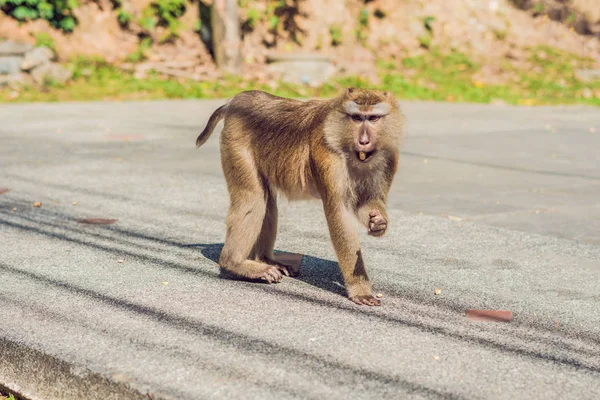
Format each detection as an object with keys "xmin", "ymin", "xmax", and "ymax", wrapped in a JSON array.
[{"xmin": 0, "ymin": 0, "xmax": 78, "ymax": 32}]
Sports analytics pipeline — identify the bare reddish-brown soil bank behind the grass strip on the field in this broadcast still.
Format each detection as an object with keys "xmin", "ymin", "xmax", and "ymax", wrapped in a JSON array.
[{"xmin": 0, "ymin": 0, "xmax": 600, "ymax": 83}]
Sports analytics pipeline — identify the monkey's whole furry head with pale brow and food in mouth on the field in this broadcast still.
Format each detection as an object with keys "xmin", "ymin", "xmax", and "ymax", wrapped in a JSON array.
[{"xmin": 327, "ymin": 88, "xmax": 402, "ymax": 163}]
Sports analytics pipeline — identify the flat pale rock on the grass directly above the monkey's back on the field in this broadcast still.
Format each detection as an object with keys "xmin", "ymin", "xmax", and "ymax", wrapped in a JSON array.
[{"xmin": 267, "ymin": 53, "xmax": 337, "ymax": 87}]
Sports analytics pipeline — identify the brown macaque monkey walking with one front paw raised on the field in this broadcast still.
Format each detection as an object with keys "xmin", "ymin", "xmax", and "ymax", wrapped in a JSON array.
[{"xmin": 196, "ymin": 88, "xmax": 404, "ymax": 306}]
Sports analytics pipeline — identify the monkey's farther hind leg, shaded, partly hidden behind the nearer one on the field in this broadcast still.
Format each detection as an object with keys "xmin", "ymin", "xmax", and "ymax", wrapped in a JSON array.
[{"xmin": 250, "ymin": 189, "xmax": 300, "ymax": 277}]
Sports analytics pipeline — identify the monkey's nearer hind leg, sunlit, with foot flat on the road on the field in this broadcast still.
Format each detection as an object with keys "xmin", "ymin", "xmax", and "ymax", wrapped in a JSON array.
[{"xmin": 219, "ymin": 150, "xmax": 285, "ymax": 283}]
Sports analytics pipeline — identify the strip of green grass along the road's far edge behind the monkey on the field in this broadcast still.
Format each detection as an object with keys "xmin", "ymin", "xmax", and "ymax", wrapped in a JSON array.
[{"xmin": 0, "ymin": 47, "xmax": 600, "ymax": 106}]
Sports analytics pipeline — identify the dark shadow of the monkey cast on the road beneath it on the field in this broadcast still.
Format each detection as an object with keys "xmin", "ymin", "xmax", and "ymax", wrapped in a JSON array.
[{"xmin": 186, "ymin": 243, "xmax": 346, "ymax": 296}]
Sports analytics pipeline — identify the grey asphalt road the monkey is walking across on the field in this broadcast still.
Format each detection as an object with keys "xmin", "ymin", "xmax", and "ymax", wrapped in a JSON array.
[{"xmin": 0, "ymin": 97, "xmax": 600, "ymax": 400}]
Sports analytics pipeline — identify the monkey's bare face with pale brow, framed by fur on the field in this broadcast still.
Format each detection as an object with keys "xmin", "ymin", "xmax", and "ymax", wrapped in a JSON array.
[{"xmin": 343, "ymin": 95, "xmax": 391, "ymax": 163}]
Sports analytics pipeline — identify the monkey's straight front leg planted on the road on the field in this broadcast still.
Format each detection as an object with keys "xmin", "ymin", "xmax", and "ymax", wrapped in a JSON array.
[{"xmin": 323, "ymin": 198, "xmax": 381, "ymax": 306}]
